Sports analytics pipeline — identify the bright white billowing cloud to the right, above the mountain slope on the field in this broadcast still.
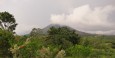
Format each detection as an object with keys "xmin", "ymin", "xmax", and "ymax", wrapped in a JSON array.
[{"xmin": 51, "ymin": 5, "xmax": 115, "ymax": 34}]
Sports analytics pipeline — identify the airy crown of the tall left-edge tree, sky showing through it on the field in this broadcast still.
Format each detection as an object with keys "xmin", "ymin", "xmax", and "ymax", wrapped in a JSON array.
[{"xmin": 0, "ymin": 11, "xmax": 17, "ymax": 32}]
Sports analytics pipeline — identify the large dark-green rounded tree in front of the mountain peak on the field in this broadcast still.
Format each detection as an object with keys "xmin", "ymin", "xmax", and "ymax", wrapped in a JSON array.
[{"xmin": 46, "ymin": 27, "xmax": 80, "ymax": 49}]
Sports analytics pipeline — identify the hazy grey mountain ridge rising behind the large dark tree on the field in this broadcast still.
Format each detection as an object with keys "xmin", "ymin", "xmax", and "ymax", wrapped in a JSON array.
[{"xmin": 30, "ymin": 24, "xmax": 94, "ymax": 36}]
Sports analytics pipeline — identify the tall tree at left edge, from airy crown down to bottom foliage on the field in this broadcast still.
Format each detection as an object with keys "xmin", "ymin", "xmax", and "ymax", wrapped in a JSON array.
[{"xmin": 0, "ymin": 12, "xmax": 17, "ymax": 58}]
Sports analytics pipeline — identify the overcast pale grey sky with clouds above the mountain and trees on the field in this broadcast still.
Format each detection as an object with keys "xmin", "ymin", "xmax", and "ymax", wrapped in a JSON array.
[{"xmin": 0, "ymin": 0, "xmax": 115, "ymax": 35}]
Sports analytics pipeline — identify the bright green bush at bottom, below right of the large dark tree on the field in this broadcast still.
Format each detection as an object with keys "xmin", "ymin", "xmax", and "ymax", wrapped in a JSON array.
[{"xmin": 67, "ymin": 45, "xmax": 92, "ymax": 58}]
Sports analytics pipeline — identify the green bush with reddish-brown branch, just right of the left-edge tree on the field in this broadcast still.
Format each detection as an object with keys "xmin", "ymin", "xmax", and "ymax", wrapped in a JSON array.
[{"xmin": 10, "ymin": 38, "xmax": 40, "ymax": 58}]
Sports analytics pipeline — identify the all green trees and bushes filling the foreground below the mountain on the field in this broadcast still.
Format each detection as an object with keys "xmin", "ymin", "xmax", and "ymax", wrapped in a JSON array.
[{"xmin": 0, "ymin": 12, "xmax": 115, "ymax": 58}]
